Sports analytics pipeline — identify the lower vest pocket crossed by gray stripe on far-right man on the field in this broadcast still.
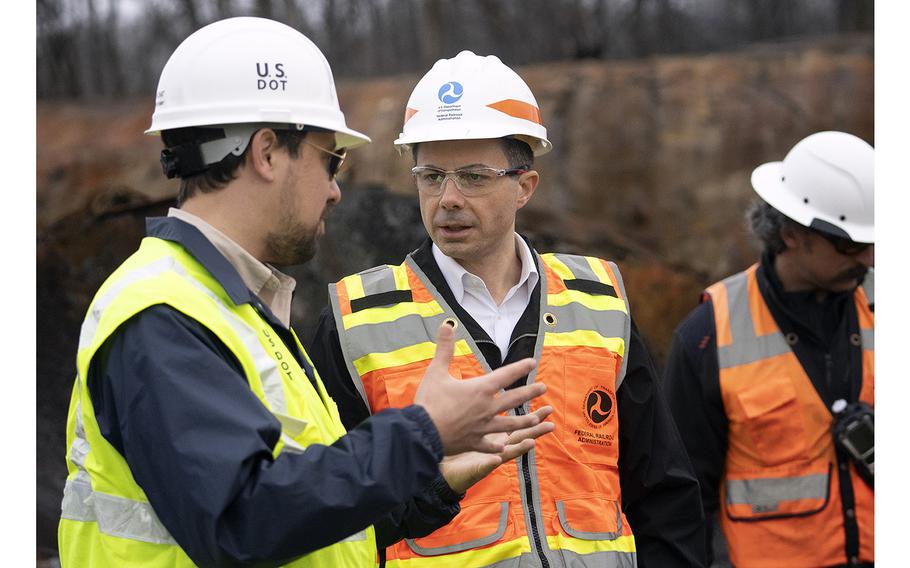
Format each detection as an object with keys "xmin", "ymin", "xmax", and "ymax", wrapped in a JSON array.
[{"xmin": 724, "ymin": 463, "xmax": 833, "ymax": 521}]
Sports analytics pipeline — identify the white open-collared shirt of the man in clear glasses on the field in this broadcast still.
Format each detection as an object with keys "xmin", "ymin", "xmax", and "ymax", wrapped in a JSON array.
[{"xmin": 433, "ymin": 233, "xmax": 540, "ymax": 359}]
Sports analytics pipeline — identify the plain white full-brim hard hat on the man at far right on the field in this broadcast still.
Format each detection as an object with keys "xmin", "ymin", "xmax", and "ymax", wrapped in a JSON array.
[{"xmin": 752, "ymin": 132, "xmax": 875, "ymax": 243}]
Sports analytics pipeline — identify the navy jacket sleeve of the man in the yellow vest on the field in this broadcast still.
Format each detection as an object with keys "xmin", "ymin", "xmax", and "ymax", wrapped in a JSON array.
[{"xmin": 88, "ymin": 306, "xmax": 450, "ymax": 566}]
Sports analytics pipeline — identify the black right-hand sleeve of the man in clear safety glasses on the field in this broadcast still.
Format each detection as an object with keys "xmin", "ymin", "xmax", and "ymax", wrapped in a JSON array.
[{"xmin": 617, "ymin": 321, "xmax": 707, "ymax": 568}]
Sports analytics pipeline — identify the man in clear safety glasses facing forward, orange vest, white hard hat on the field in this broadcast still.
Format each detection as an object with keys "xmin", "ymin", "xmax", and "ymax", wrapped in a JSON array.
[{"xmin": 311, "ymin": 51, "xmax": 704, "ymax": 568}]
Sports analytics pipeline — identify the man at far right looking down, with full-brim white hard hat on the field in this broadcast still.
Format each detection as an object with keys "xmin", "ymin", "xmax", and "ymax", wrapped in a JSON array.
[{"xmin": 664, "ymin": 132, "xmax": 875, "ymax": 567}]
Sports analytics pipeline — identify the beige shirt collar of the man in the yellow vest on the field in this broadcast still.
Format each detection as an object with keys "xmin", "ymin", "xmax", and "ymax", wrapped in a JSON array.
[{"xmin": 167, "ymin": 207, "xmax": 297, "ymax": 327}]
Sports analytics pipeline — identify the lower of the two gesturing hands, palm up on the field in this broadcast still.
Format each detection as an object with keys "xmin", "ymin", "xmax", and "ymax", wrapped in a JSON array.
[{"xmin": 439, "ymin": 406, "xmax": 556, "ymax": 493}]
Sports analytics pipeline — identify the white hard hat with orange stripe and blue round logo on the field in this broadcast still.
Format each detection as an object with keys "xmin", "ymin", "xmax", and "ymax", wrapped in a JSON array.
[{"xmin": 395, "ymin": 51, "xmax": 552, "ymax": 156}]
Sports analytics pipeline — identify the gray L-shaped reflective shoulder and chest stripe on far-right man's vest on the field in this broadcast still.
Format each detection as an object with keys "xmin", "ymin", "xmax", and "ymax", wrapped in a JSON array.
[{"xmin": 717, "ymin": 272, "xmax": 791, "ymax": 369}]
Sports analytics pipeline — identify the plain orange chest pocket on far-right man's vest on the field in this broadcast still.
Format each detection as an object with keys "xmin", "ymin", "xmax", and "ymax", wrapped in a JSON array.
[{"xmin": 736, "ymin": 376, "xmax": 808, "ymax": 466}]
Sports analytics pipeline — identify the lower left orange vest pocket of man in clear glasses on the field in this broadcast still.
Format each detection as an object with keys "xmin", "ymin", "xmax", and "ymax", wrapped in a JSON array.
[{"xmin": 405, "ymin": 501, "xmax": 509, "ymax": 556}]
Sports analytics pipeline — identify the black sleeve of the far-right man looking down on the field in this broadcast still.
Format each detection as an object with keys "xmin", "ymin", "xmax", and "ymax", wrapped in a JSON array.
[{"xmin": 663, "ymin": 300, "xmax": 727, "ymax": 562}]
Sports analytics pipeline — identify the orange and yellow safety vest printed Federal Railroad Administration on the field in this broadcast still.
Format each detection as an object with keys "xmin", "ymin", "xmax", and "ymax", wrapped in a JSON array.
[{"xmin": 329, "ymin": 254, "xmax": 636, "ymax": 568}]
